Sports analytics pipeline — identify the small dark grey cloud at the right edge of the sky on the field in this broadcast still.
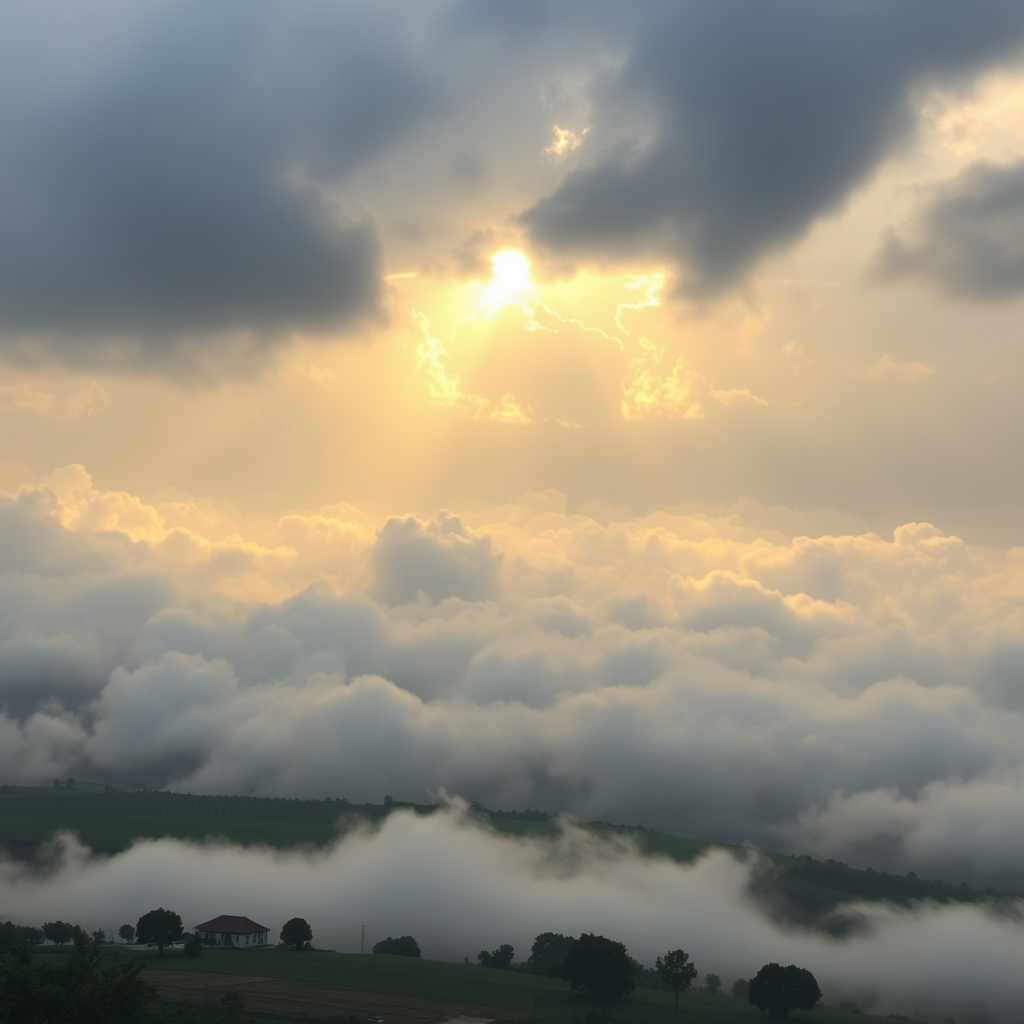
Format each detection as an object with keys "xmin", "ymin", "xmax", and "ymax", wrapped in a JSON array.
[{"xmin": 873, "ymin": 161, "xmax": 1024, "ymax": 299}]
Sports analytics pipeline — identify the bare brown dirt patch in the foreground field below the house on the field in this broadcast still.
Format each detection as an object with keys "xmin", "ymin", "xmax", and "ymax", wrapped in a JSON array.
[{"xmin": 145, "ymin": 971, "xmax": 525, "ymax": 1024}]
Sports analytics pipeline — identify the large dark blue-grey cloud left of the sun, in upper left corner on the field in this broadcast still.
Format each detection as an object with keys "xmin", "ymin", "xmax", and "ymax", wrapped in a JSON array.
[{"xmin": 0, "ymin": 3, "xmax": 433, "ymax": 362}]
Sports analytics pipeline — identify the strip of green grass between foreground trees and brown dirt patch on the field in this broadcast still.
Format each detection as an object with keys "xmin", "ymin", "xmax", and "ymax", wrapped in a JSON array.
[{"xmin": 36, "ymin": 947, "xmax": 884, "ymax": 1024}]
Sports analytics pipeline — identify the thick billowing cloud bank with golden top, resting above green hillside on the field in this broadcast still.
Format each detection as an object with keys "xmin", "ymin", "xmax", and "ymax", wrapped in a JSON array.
[{"xmin": 6, "ymin": 469, "xmax": 1024, "ymax": 887}]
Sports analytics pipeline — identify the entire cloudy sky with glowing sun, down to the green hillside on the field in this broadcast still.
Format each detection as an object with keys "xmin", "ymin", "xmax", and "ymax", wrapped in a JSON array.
[{"xmin": 0, "ymin": 0, "xmax": 1024, "ymax": 1015}]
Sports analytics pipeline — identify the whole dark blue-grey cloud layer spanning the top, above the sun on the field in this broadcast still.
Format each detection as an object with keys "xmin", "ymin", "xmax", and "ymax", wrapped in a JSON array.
[{"xmin": 0, "ymin": 0, "xmax": 1024, "ymax": 373}]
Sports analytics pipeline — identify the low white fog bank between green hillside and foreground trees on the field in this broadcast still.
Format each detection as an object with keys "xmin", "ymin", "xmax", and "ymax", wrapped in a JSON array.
[{"xmin": 0, "ymin": 805, "xmax": 1024, "ymax": 1024}]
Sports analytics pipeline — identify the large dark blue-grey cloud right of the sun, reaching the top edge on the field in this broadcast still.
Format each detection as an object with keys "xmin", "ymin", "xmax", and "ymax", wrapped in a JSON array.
[{"xmin": 521, "ymin": 0, "xmax": 1024, "ymax": 293}]
